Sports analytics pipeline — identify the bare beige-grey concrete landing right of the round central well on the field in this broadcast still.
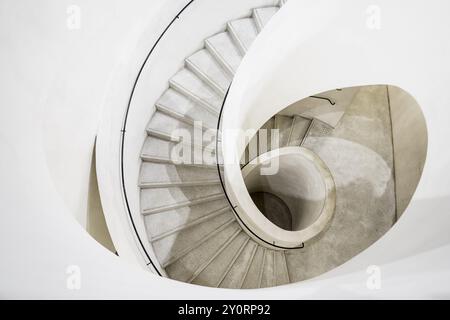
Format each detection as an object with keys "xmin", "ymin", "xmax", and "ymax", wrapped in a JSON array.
[{"xmin": 286, "ymin": 86, "xmax": 396, "ymax": 282}]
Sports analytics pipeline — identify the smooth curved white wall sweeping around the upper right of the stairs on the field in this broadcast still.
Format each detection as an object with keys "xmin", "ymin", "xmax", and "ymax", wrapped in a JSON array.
[{"xmin": 223, "ymin": 0, "xmax": 450, "ymax": 284}]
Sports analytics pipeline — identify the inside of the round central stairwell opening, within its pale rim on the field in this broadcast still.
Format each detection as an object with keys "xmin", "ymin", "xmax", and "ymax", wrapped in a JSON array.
[{"xmin": 243, "ymin": 147, "xmax": 329, "ymax": 231}]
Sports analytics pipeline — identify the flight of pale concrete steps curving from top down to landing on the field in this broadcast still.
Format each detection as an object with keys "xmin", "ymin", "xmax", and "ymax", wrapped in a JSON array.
[{"xmin": 139, "ymin": 1, "xmax": 298, "ymax": 288}]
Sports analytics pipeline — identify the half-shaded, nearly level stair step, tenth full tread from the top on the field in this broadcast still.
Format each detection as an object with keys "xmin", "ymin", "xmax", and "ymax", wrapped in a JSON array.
[{"xmin": 141, "ymin": 184, "xmax": 225, "ymax": 215}]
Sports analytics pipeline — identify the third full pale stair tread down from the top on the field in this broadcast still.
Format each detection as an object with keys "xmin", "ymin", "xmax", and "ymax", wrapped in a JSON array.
[{"xmin": 205, "ymin": 32, "xmax": 242, "ymax": 76}]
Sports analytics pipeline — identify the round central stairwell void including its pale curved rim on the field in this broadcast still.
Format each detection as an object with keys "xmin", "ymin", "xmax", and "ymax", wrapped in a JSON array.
[{"xmin": 242, "ymin": 146, "xmax": 336, "ymax": 238}]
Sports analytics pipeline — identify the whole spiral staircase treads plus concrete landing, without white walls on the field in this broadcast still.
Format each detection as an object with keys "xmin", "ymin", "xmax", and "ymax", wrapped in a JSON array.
[{"xmin": 129, "ymin": 1, "xmax": 428, "ymax": 289}]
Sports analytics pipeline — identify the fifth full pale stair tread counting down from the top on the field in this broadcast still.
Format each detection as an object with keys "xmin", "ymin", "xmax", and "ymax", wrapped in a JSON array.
[{"xmin": 169, "ymin": 68, "xmax": 223, "ymax": 115}]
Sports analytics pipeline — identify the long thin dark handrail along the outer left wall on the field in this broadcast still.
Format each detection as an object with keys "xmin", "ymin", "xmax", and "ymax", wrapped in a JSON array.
[{"xmin": 120, "ymin": 0, "xmax": 195, "ymax": 276}]
